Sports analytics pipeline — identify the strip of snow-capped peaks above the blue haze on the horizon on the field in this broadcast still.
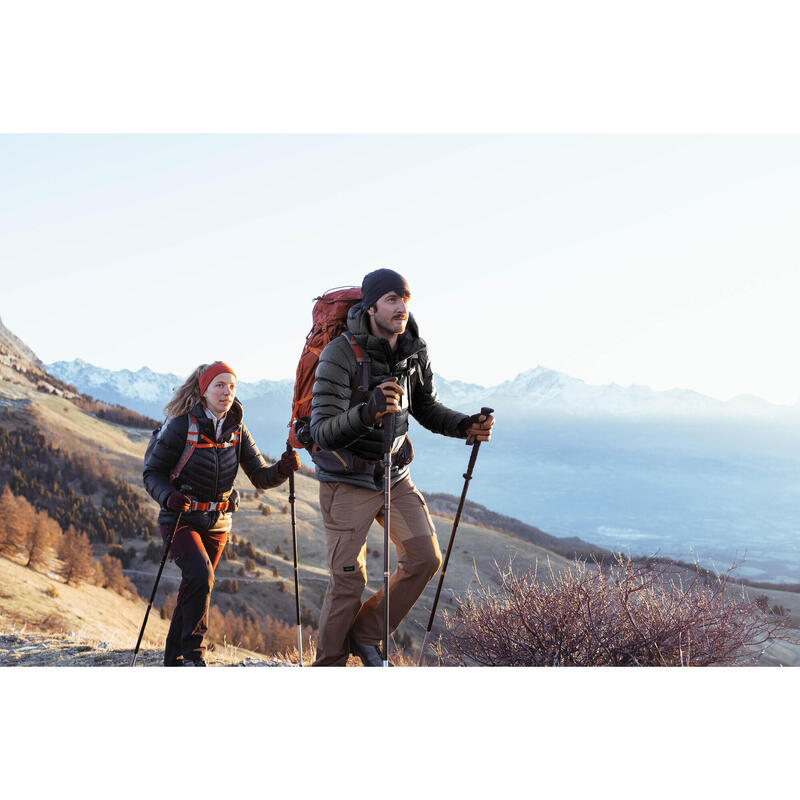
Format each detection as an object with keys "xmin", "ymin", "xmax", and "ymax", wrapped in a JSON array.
[{"xmin": 47, "ymin": 359, "xmax": 800, "ymax": 418}]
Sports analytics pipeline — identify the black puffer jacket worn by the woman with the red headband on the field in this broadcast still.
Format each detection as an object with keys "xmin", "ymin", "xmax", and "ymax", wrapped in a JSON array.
[{"xmin": 143, "ymin": 399, "xmax": 286, "ymax": 531}]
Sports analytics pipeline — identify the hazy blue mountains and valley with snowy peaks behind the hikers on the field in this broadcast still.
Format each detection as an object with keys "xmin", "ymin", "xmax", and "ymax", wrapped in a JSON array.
[{"xmin": 29, "ymin": 360, "xmax": 800, "ymax": 582}]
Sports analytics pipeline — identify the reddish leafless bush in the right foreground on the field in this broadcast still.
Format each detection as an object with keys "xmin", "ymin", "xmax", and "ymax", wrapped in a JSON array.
[{"xmin": 438, "ymin": 556, "xmax": 788, "ymax": 666}]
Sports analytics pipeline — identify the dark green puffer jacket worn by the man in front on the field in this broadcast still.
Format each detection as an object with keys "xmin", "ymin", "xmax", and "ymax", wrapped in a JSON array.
[{"xmin": 311, "ymin": 303, "xmax": 467, "ymax": 489}]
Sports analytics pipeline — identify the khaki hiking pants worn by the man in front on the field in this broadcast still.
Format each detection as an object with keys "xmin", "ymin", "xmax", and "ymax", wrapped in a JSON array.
[{"xmin": 314, "ymin": 478, "xmax": 442, "ymax": 667}]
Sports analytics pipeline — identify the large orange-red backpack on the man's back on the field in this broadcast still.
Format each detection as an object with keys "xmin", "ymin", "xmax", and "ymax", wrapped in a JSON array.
[{"xmin": 289, "ymin": 286, "xmax": 369, "ymax": 450}]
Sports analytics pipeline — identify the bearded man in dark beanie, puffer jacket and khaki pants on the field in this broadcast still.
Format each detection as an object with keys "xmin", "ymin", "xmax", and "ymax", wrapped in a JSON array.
[{"xmin": 311, "ymin": 269, "xmax": 494, "ymax": 667}]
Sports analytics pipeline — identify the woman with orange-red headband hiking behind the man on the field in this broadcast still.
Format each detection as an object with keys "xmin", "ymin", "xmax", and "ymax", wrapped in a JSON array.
[{"xmin": 144, "ymin": 361, "xmax": 300, "ymax": 667}]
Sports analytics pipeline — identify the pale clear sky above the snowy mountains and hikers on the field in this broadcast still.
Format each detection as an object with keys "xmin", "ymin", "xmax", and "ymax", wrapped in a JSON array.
[{"xmin": 0, "ymin": 134, "xmax": 800, "ymax": 403}]
